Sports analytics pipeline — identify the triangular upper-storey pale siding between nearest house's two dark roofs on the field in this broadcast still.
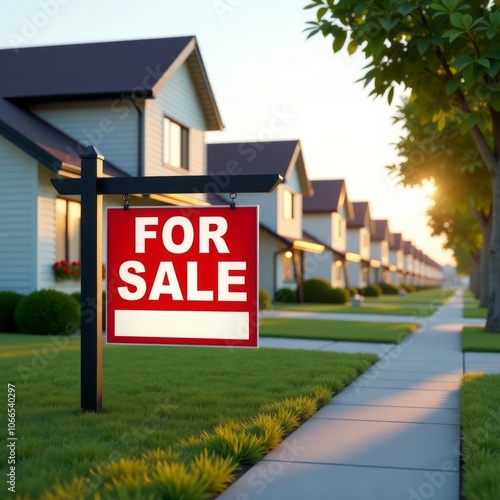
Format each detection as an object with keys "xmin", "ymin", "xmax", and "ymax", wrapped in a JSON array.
[{"xmin": 30, "ymin": 99, "xmax": 139, "ymax": 175}]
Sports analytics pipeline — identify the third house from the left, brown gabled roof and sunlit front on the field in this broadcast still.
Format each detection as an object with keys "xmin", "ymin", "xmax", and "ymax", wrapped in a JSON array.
[{"xmin": 303, "ymin": 179, "xmax": 354, "ymax": 287}]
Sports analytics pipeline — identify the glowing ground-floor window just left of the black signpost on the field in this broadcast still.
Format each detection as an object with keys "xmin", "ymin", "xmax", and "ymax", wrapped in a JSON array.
[{"xmin": 56, "ymin": 198, "xmax": 82, "ymax": 262}]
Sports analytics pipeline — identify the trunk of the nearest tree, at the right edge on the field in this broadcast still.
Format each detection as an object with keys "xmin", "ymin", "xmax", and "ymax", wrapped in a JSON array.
[{"xmin": 486, "ymin": 171, "xmax": 500, "ymax": 333}]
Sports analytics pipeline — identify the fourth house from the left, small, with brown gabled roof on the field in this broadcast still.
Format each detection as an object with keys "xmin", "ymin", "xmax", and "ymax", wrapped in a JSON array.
[{"xmin": 346, "ymin": 201, "xmax": 373, "ymax": 288}]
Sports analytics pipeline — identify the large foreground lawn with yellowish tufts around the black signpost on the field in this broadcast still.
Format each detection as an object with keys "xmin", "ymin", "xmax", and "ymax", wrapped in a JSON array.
[{"xmin": 0, "ymin": 334, "xmax": 378, "ymax": 500}]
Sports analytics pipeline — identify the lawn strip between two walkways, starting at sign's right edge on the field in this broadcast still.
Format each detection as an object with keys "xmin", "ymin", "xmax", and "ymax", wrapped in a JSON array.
[{"xmin": 260, "ymin": 318, "xmax": 418, "ymax": 344}]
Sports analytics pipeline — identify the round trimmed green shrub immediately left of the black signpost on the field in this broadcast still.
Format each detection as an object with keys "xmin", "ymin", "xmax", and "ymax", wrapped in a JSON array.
[{"xmin": 14, "ymin": 290, "xmax": 80, "ymax": 335}]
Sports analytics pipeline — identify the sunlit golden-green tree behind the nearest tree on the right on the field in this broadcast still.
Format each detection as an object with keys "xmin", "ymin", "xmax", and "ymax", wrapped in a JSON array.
[{"xmin": 387, "ymin": 102, "xmax": 492, "ymax": 307}]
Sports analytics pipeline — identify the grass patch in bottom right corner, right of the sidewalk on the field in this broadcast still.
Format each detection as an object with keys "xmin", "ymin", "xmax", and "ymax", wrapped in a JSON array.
[{"xmin": 460, "ymin": 373, "xmax": 500, "ymax": 500}]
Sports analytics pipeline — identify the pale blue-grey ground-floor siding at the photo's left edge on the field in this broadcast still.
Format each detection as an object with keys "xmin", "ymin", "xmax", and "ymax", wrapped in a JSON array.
[{"xmin": 0, "ymin": 137, "xmax": 38, "ymax": 294}]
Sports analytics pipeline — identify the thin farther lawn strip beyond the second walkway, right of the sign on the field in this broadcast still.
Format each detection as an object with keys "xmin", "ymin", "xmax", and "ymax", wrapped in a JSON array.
[{"xmin": 274, "ymin": 302, "xmax": 436, "ymax": 316}]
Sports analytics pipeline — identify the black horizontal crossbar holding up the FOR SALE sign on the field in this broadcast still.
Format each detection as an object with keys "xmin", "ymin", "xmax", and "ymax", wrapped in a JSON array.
[{"xmin": 50, "ymin": 174, "xmax": 283, "ymax": 194}]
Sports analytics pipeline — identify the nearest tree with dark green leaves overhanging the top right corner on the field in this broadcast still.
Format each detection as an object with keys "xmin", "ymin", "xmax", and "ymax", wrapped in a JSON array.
[{"xmin": 306, "ymin": 0, "xmax": 500, "ymax": 332}]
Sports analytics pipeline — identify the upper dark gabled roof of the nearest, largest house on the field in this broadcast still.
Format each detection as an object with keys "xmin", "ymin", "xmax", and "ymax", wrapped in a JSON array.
[{"xmin": 0, "ymin": 36, "xmax": 223, "ymax": 130}]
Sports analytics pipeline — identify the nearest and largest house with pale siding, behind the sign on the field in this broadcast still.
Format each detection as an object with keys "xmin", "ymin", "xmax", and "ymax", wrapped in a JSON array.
[{"xmin": 0, "ymin": 36, "xmax": 222, "ymax": 293}]
